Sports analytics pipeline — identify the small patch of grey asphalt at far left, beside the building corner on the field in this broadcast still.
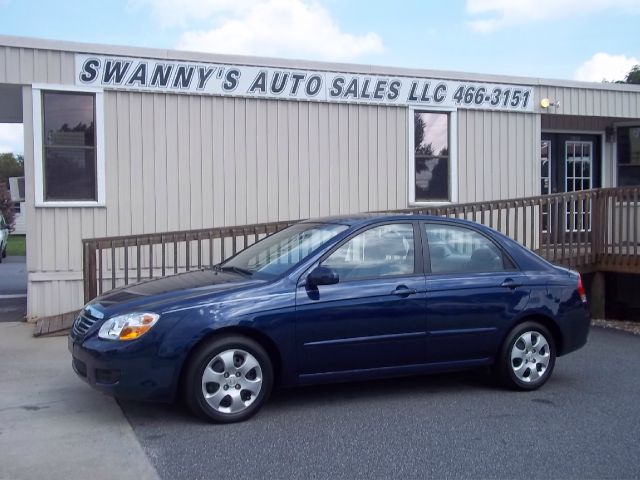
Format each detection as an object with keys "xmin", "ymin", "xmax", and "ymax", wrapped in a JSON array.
[{"xmin": 0, "ymin": 256, "xmax": 27, "ymax": 322}]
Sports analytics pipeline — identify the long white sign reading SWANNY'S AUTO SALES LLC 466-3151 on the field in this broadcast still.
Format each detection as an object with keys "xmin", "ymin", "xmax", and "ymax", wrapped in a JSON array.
[{"xmin": 75, "ymin": 54, "xmax": 534, "ymax": 112}]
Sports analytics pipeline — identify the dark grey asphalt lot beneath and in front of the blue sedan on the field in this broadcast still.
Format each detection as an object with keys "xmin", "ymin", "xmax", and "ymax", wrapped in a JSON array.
[{"xmin": 121, "ymin": 328, "xmax": 640, "ymax": 479}]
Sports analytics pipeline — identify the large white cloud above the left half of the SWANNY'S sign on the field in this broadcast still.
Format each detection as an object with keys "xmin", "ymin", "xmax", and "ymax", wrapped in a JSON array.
[{"xmin": 130, "ymin": 0, "xmax": 384, "ymax": 61}]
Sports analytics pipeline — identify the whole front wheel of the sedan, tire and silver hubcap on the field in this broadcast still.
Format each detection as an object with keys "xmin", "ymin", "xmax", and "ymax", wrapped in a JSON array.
[{"xmin": 185, "ymin": 336, "xmax": 273, "ymax": 423}]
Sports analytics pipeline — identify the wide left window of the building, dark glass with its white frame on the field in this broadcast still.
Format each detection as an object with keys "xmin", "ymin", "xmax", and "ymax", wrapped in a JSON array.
[{"xmin": 33, "ymin": 85, "xmax": 104, "ymax": 207}]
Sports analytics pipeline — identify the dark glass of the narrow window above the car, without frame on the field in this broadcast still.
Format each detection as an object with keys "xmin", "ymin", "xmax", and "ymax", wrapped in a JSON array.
[{"xmin": 413, "ymin": 111, "xmax": 451, "ymax": 203}]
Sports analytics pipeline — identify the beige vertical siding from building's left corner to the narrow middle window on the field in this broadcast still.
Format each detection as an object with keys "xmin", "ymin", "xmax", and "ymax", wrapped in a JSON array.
[{"xmin": 24, "ymin": 89, "xmax": 408, "ymax": 316}]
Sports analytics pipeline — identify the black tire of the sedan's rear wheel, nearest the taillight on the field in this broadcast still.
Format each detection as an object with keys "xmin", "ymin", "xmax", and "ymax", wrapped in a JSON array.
[{"xmin": 496, "ymin": 322, "xmax": 556, "ymax": 390}]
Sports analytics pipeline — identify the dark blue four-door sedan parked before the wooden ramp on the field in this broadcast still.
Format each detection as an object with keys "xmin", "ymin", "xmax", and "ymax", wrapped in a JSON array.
[{"xmin": 69, "ymin": 215, "xmax": 589, "ymax": 422}]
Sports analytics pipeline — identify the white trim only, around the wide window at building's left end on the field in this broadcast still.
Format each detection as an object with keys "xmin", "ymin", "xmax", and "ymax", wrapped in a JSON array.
[{"xmin": 31, "ymin": 84, "xmax": 106, "ymax": 207}]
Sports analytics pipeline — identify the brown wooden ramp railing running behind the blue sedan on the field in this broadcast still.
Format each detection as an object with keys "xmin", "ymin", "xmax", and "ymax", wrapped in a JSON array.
[{"xmin": 83, "ymin": 187, "xmax": 640, "ymax": 301}]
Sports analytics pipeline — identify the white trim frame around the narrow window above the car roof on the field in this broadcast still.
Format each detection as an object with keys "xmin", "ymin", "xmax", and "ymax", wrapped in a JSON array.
[{"xmin": 407, "ymin": 107, "xmax": 458, "ymax": 207}]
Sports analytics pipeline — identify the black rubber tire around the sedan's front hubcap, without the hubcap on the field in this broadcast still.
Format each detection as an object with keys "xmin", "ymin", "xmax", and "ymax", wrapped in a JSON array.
[{"xmin": 184, "ymin": 335, "xmax": 273, "ymax": 423}]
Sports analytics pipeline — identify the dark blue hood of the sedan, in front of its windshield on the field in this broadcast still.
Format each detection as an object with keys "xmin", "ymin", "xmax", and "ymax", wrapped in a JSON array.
[{"xmin": 86, "ymin": 269, "xmax": 265, "ymax": 318}]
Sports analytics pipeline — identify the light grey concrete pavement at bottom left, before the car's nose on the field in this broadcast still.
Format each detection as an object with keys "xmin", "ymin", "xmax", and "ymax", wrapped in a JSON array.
[{"xmin": 0, "ymin": 322, "xmax": 159, "ymax": 480}]
